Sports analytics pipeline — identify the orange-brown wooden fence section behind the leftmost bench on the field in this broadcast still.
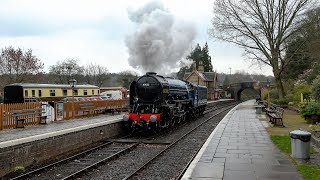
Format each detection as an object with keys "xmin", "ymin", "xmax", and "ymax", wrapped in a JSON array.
[{"xmin": 0, "ymin": 103, "xmax": 41, "ymax": 130}]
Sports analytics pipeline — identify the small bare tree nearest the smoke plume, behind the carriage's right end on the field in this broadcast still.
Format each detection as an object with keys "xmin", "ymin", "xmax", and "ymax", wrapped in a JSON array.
[{"xmin": 84, "ymin": 63, "xmax": 108, "ymax": 87}]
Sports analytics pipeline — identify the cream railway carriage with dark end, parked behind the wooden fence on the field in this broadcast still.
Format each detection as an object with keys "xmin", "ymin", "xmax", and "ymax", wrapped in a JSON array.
[{"xmin": 4, "ymin": 83, "xmax": 100, "ymax": 103}]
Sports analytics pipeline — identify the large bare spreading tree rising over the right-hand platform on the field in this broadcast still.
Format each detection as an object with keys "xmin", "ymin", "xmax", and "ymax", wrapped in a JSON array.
[{"xmin": 210, "ymin": 0, "xmax": 313, "ymax": 98}]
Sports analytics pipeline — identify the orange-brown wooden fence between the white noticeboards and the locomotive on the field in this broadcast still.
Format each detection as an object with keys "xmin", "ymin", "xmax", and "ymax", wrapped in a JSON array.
[{"xmin": 63, "ymin": 99, "xmax": 128, "ymax": 120}]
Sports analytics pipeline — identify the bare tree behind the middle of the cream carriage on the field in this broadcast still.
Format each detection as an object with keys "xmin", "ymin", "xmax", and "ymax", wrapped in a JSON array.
[{"xmin": 49, "ymin": 58, "xmax": 84, "ymax": 84}]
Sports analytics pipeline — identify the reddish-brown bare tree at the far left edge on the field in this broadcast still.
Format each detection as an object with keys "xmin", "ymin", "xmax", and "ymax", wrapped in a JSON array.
[{"xmin": 0, "ymin": 46, "xmax": 43, "ymax": 83}]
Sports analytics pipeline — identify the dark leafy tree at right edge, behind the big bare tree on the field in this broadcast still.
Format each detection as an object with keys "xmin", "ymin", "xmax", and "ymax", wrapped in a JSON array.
[{"xmin": 284, "ymin": 8, "xmax": 320, "ymax": 83}]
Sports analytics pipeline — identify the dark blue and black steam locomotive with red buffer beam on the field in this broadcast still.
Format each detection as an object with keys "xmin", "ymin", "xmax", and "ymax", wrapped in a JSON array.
[{"xmin": 123, "ymin": 72, "xmax": 208, "ymax": 132}]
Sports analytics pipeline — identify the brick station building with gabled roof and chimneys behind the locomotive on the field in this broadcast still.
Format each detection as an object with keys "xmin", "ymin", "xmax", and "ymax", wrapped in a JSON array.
[{"xmin": 183, "ymin": 62, "xmax": 222, "ymax": 100}]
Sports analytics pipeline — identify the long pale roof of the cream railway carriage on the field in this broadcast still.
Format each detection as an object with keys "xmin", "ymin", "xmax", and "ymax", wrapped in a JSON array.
[{"xmin": 8, "ymin": 83, "xmax": 99, "ymax": 89}]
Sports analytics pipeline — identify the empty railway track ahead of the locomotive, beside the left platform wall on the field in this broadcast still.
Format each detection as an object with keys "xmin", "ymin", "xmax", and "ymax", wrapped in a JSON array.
[{"xmin": 12, "ymin": 142, "xmax": 138, "ymax": 180}]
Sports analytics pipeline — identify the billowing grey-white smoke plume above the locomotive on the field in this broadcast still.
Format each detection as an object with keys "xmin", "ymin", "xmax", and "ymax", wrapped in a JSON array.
[{"xmin": 125, "ymin": 1, "xmax": 195, "ymax": 74}]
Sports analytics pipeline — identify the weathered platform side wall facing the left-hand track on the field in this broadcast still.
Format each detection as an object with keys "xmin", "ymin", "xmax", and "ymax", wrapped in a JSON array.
[{"xmin": 0, "ymin": 122, "xmax": 124, "ymax": 177}]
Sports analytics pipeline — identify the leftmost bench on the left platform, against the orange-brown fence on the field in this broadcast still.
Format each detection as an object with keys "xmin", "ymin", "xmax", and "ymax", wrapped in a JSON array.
[{"xmin": 11, "ymin": 108, "xmax": 47, "ymax": 128}]
